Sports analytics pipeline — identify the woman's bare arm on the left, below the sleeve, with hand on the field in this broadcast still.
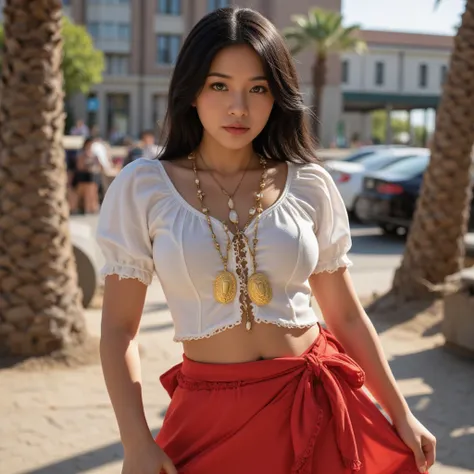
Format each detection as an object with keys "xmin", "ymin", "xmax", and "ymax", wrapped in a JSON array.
[{"xmin": 100, "ymin": 275, "xmax": 177, "ymax": 474}]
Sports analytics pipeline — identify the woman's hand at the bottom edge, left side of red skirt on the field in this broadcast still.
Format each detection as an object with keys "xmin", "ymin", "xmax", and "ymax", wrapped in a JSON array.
[{"xmin": 122, "ymin": 439, "xmax": 178, "ymax": 474}]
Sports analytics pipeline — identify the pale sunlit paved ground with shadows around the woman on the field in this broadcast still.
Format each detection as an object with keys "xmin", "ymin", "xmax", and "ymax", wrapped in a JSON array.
[{"xmin": 0, "ymin": 281, "xmax": 474, "ymax": 474}]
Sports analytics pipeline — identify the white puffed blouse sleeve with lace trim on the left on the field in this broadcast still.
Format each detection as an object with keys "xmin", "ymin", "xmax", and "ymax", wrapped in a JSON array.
[{"xmin": 97, "ymin": 160, "xmax": 154, "ymax": 285}]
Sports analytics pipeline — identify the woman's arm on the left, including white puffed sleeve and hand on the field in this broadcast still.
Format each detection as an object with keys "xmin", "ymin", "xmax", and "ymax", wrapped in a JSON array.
[{"xmin": 97, "ymin": 163, "xmax": 176, "ymax": 474}]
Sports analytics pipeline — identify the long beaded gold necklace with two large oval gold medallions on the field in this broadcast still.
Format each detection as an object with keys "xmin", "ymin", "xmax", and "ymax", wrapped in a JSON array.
[{"xmin": 189, "ymin": 153, "xmax": 272, "ymax": 330}]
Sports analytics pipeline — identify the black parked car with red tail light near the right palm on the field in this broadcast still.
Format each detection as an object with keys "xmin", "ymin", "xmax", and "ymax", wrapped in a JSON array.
[{"xmin": 357, "ymin": 155, "xmax": 474, "ymax": 234}]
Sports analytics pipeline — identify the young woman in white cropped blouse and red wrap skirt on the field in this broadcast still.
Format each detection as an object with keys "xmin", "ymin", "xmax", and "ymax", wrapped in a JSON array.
[{"xmin": 98, "ymin": 8, "xmax": 435, "ymax": 474}]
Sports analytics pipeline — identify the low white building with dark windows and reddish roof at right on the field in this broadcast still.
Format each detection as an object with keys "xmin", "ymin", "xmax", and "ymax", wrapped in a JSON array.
[{"xmin": 341, "ymin": 30, "xmax": 453, "ymax": 142}]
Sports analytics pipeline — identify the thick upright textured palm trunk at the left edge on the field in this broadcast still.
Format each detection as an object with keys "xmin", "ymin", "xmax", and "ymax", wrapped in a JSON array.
[{"xmin": 0, "ymin": 0, "xmax": 86, "ymax": 356}]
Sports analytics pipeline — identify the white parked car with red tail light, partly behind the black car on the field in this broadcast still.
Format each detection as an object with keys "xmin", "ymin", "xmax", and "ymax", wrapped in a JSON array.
[{"xmin": 325, "ymin": 147, "xmax": 429, "ymax": 219}]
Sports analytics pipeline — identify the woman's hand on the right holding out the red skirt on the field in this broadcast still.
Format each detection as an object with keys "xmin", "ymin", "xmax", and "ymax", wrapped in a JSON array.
[{"xmin": 394, "ymin": 413, "xmax": 436, "ymax": 472}]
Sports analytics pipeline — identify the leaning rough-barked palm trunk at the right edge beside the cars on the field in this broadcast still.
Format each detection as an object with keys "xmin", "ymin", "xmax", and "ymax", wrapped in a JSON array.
[{"xmin": 393, "ymin": 0, "xmax": 474, "ymax": 300}]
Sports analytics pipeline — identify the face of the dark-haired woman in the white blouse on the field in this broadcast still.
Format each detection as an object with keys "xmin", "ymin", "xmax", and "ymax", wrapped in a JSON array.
[{"xmin": 193, "ymin": 45, "xmax": 274, "ymax": 150}]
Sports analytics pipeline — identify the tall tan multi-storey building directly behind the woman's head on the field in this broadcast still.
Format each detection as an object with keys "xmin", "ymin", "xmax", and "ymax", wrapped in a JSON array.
[{"xmin": 64, "ymin": 0, "xmax": 341, "ymax": 144}]
